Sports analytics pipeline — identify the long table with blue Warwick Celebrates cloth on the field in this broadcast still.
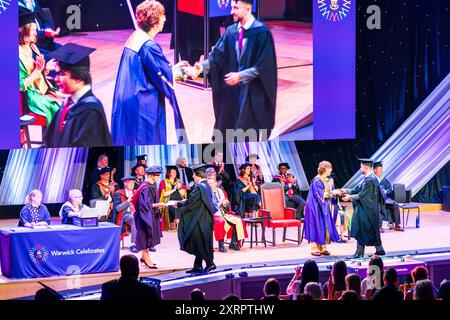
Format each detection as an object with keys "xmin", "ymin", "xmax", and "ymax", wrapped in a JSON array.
[{"xmin": 0, "ymin": 222, "xmax": 120, "ymax": 279}]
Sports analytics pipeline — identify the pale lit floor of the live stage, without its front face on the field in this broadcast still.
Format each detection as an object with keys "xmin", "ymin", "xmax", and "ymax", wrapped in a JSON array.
[{"xmin": 0, "ymin": 204, "xmax": 450, "ymax": 300}]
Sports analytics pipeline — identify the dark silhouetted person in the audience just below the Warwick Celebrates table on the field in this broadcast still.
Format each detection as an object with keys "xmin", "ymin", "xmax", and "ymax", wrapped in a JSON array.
[{"xmin": 100, "ymin": 254, "xmax": 161, "ymax": 301}]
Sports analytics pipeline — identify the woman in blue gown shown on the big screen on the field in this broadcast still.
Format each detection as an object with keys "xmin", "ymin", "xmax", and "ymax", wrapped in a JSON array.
[{"xmin": 111, "ymin": 0, "xmax": 189, "ymax": 146}]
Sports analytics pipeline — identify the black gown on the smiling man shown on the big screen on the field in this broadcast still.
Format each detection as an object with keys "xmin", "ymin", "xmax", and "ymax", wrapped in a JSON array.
[{"xmin": 208, "ymin": 20, "xmax": 277, "ymax": 134}]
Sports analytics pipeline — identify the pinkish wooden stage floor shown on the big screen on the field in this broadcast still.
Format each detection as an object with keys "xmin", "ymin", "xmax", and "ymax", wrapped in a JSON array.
[{"xmin": 30, "ymin": 21, "xmax": 313, "ymax": 144}]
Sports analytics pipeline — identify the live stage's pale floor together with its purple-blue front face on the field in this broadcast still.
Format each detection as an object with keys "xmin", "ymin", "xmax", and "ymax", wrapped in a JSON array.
[{"xmin": 0, "ymin": 204, "xmax": 450, "ymax": 300}]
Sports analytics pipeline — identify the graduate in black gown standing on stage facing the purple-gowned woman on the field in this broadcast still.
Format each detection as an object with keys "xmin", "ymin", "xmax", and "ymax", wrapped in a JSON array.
[{"xmin": 175, "ymin": 165, "xmax": 217, "ymax": 273}]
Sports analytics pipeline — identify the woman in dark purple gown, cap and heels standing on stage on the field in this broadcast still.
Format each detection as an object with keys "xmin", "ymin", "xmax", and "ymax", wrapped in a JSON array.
[{"xmin": 131, "ymin": 166, "xmax": 167, "ymax": 269}]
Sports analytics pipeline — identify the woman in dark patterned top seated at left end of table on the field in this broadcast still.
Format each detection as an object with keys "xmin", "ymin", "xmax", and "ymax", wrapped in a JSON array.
[{"xmin": 19, "ymin": 189, "xmax": 50, "ymax": 228}]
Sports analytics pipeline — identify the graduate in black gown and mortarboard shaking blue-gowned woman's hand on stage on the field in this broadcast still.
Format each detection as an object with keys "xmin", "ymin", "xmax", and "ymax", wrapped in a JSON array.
[{"xmin": 341, "ymin": 159, "xmax": 385, "ymax": 258}]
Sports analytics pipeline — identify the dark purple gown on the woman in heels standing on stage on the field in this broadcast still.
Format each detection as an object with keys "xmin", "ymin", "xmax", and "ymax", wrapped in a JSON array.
[{"xmin": 133, "ymin": 183, "xmax": 162, "ymax": 251}]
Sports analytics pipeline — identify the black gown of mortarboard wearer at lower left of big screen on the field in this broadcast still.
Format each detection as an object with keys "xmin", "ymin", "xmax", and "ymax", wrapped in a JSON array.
[{"xmin": 45, "ymin": 90, "xmax": 111, "ymax": 147}]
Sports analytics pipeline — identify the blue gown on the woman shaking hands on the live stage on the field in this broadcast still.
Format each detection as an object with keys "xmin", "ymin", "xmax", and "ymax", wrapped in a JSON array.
[{"xmin": 305, "ymin": 177, "xmax": 339, "ymax": 245}]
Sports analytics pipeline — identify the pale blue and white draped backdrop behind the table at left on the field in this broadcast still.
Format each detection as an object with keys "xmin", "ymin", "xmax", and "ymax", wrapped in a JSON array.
[{"xmin": 0, "ymin": 148, "xmax": 88, "ymax": 205}]
